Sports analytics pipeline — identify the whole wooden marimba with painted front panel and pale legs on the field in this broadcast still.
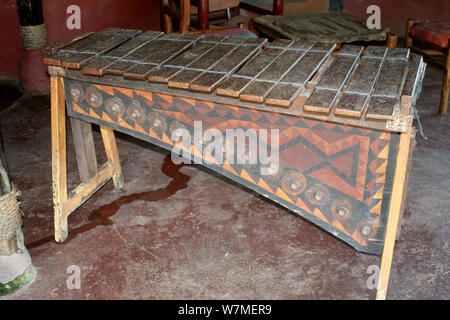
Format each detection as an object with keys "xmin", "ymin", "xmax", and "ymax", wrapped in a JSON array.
[{"xmin": 44, "ymin": 29, "xmax": 425, "ymax": 298}]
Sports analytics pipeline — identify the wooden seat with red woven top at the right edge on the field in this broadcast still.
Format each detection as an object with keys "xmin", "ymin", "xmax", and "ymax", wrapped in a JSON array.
[{"xmin": 405, "ymin": 19, "xmax": 450, "ymax": 116}]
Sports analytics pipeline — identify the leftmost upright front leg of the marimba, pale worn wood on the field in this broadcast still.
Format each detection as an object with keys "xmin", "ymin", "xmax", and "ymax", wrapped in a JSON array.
[{"xmin": 50, "ymin": 76, "xmax": 68, "ymax": 242}]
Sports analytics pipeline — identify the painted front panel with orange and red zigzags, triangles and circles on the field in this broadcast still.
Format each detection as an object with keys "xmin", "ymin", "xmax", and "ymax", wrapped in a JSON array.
[{"xmin": 65, "ymin": 79, "xmax": 398, "ymax": 252}]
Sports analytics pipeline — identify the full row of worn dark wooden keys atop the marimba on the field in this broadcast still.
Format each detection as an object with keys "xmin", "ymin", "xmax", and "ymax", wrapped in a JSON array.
[{"xmin": 44, "ymin": 29, "xmax": 425, "ymax": 131}]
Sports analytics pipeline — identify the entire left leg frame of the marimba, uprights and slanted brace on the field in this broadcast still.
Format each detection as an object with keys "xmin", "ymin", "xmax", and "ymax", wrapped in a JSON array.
[{"xmin": 50, "ymin": 71, "xmax": 123, "ymax": 242}]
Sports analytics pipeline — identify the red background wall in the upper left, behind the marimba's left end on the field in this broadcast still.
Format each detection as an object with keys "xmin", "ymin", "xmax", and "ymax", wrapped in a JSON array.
[{"xmin": 0, "ymin": 0, "xmax": 160, "ymax": 80}]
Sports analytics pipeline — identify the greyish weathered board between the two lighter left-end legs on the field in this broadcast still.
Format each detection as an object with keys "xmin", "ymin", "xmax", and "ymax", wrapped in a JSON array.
[{"xmin": 70, "ymin": 118, "xmax": 98, "ymax": 183}]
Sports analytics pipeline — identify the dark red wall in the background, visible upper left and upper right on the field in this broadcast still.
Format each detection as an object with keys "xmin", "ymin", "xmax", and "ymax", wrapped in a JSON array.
[{"xmin": 0, "ymin": 0, "xmax": 450, "ymax": 80}]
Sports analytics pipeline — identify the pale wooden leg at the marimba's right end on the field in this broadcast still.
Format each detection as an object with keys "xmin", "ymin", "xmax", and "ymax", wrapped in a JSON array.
[{"xmin": 377, "ymin": 128, "xmax": 412, "ymax": 300}]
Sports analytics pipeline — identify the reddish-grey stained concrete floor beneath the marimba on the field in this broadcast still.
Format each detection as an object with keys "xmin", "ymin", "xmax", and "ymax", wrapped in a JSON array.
[{"xmin": 0, "ymin": 66, "xmax": 450, "ymax": 299}]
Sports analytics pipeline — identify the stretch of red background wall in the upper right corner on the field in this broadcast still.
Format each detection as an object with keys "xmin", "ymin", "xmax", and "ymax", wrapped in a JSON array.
[{"xmin": 344, "ymin": 0, "xmax": 450, "ymax": 37}]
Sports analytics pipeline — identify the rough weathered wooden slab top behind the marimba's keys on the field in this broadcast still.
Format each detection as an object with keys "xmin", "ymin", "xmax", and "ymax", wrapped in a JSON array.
[{"xmin": 254, "ymin": 12, "xmax": 389, "ymax": 42}]
